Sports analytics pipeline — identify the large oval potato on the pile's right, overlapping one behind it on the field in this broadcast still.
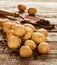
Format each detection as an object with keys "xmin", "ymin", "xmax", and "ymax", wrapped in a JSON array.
[{"xmin": 32, "ymin": 32, "xmax": 46, "ymax": 44}]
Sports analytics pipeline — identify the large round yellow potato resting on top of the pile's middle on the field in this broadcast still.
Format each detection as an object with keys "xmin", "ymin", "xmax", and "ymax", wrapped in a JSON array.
[{"xmin": 14, "ymin": 25, "xmax": 26, "ymax": 37}]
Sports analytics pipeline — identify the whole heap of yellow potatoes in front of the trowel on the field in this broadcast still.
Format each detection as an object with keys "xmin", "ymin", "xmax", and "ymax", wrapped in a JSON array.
[{"xmin": 0, "ymin": 19, "xmax": 50, "ymax": 57}]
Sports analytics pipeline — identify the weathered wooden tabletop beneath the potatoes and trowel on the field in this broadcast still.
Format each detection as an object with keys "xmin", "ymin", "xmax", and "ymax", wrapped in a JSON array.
[{"xmin": 0, "ymin": 1, "xmax": 57, "ymax": 65}]
